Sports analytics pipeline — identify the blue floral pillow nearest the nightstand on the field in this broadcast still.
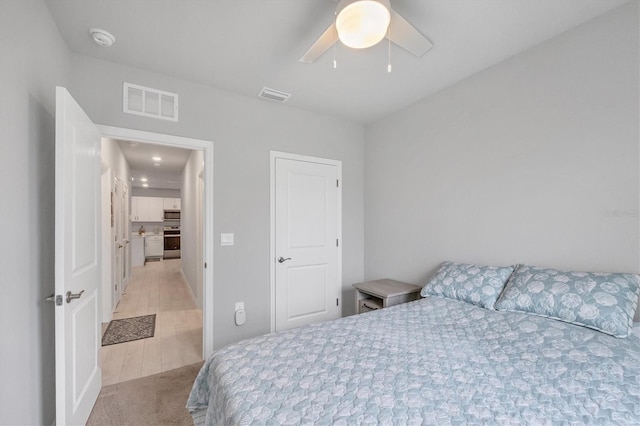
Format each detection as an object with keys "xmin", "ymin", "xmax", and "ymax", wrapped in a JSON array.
[{"xmin": 420, "ymin": 262, "xmax": 514, "ymax": 309}]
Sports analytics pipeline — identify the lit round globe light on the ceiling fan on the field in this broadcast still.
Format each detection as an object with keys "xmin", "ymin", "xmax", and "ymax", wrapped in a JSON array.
[{"xmin": 336, "ymin": 0, "xmax": 391, "ymax": 49}]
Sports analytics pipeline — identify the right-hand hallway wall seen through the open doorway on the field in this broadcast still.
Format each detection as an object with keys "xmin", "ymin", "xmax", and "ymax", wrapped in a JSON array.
[{"xmin": 180, "ymin": 150, "xmax": 204, "ymax": 308}]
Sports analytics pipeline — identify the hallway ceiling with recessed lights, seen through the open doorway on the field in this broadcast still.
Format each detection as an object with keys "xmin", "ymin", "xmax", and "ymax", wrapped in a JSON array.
[{"xmin": 111, "ymin": 140, "xmax": 191, "ymax": 189}]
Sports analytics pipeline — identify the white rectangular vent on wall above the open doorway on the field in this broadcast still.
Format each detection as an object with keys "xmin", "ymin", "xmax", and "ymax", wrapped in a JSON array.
[{"xmin": 122, "ymin": 83, "xmax": 178, "ymax": 121}]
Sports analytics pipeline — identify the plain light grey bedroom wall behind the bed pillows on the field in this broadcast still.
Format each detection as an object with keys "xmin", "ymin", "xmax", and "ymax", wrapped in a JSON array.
[{"xmin": 365, "ymin": 2, "xmax": 640, "ymax": 310}]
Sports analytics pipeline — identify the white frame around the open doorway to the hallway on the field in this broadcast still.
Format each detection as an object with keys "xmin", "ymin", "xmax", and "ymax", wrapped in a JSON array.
[{"xmin": 96, "ymin": 124, "xmax": 214, "ymax": 359}]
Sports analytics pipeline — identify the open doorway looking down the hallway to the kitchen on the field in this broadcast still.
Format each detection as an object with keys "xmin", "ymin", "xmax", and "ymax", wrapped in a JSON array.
[{"xmin": 101, "ymin": 138, "xmax": 203, "ymax": 386}]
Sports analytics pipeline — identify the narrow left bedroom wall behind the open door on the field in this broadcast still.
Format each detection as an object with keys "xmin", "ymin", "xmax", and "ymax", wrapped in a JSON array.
[{"xmin": 0, "ymin": 0, "xmax": 70, "ymax": 425}]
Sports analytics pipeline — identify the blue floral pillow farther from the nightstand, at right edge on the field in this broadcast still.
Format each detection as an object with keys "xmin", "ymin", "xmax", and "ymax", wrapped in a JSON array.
[{"xmin": 495, "ymin": 265, "xmax": 640, "ymax": 337}]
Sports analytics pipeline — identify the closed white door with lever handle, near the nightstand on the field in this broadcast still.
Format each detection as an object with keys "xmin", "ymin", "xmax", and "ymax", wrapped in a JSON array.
[{"xmin": 273, "ymin": 158, "xmax": 342, "ymax": 331}]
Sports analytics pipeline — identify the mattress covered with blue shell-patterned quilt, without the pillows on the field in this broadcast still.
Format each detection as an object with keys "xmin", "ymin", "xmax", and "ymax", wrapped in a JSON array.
[{"xmin": 187, "ymin": 298, "xmax": 640, "ymax": 425}]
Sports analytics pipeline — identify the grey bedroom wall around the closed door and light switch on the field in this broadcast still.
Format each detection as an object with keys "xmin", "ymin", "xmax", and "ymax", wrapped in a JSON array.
[{"xmin": 72, "ymin": 55, "xmax": 364, "ymax": 347}]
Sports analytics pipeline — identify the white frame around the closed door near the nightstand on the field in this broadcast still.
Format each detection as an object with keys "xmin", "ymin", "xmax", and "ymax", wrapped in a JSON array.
[{"xmin": 269, "ymin": 151, "xmax": 344, "ymax": 333}]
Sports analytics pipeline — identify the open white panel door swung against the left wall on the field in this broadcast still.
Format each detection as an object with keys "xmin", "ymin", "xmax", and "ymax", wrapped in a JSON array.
[{"xmin": 55, "ymin": 87, "xmax": 101, "ymax": 426}]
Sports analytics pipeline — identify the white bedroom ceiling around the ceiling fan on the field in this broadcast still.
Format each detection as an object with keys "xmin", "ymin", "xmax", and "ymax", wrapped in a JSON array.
[{"xmin": 46, "ymin": 0, "xmax": 627, "ymax": 123}]
